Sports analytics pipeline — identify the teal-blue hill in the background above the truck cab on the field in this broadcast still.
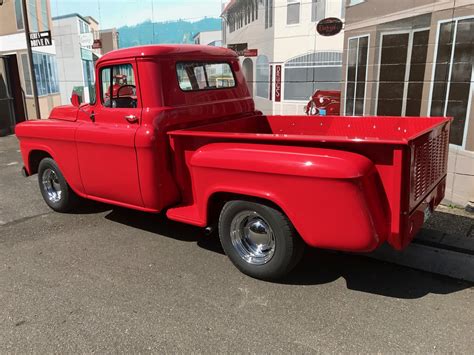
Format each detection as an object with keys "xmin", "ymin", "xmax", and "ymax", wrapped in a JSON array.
[{"xmin": 118, "ymin": 17, "xmax": 221, "ymax": 48}]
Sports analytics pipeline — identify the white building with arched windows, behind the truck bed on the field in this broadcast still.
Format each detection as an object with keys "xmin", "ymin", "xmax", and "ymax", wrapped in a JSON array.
[{"xmin": 222, "ymin": 0, "xmax": 345, "ymax": 115}]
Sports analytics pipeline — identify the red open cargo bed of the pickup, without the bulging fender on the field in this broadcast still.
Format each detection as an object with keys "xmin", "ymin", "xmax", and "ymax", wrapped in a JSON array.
[{"xmin": 168, "ymin": 115, "xmax": 450, "ymax": 249}]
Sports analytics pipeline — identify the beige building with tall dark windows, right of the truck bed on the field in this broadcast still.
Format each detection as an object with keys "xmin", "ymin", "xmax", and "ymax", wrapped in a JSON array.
[{"xmin": 341, "ymin": 0, "xmax": 474, "ymax": 206}]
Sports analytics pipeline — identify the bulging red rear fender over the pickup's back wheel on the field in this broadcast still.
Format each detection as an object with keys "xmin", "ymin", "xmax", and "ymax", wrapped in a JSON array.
[{"xmin": 189, "ymin": 143, "xmax": 388, "ymax": 251}]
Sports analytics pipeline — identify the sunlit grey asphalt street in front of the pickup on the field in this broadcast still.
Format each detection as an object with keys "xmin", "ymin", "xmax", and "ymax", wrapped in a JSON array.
[{"xmin": 0, "ymin": 136, "xmax": 474, "ymax": 353}]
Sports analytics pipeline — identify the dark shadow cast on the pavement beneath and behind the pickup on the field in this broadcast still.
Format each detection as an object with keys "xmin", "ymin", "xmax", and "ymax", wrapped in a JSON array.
[{"xmin": 105, "ymin": 207, "xmax": 473, "ymax": 299}]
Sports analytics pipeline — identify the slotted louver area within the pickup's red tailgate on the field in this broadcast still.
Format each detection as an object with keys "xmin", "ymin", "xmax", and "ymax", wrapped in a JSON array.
[{"xmin": 414, "ymin": 130, "xmax": 449, "ymax": 200}]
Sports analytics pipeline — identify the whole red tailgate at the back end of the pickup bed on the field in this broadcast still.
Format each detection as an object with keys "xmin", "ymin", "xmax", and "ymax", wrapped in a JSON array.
[{"xmin": 409, "ymin": 121, "xmax": 450, "ymax": 212}]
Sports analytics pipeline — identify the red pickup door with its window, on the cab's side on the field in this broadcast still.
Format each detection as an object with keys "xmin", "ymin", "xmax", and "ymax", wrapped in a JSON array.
[{"xmin": 76, "ymin": 61, "xmax": 143, "ymax": 206}]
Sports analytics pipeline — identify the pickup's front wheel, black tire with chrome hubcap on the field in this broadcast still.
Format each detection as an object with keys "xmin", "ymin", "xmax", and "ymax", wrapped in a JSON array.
[{"xmin": 38, "ymin": 158, "xmax": 79, "ymax": 212}]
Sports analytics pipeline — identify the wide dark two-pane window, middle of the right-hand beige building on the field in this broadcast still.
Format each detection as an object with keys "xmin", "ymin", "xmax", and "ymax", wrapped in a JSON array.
[{"xmin": 376, "ymin": 29, "xmax": 429, "ymax": 116}]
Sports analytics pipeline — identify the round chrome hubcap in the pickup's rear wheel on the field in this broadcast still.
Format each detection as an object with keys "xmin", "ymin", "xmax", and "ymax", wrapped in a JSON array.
[{"xmin": 230, "ymin": 211, "xmax": 275, "ymax": 265}]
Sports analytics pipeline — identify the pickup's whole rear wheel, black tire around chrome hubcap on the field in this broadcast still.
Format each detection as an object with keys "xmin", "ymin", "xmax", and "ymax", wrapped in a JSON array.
[{"xmin": 219, "ymin": 200, "xmax": 304, "ymax": 281}]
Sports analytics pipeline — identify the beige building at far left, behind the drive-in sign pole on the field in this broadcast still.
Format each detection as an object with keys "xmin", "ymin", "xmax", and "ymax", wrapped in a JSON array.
[{"xmin": 0, "ymin": 0, "xmax": 60, "ymax": 135}]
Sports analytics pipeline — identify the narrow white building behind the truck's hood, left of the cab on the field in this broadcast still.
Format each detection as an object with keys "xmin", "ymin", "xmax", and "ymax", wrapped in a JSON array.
[{"xmin": 53, "ymin": 14, "xmax": 100, "ymax": 104}]
